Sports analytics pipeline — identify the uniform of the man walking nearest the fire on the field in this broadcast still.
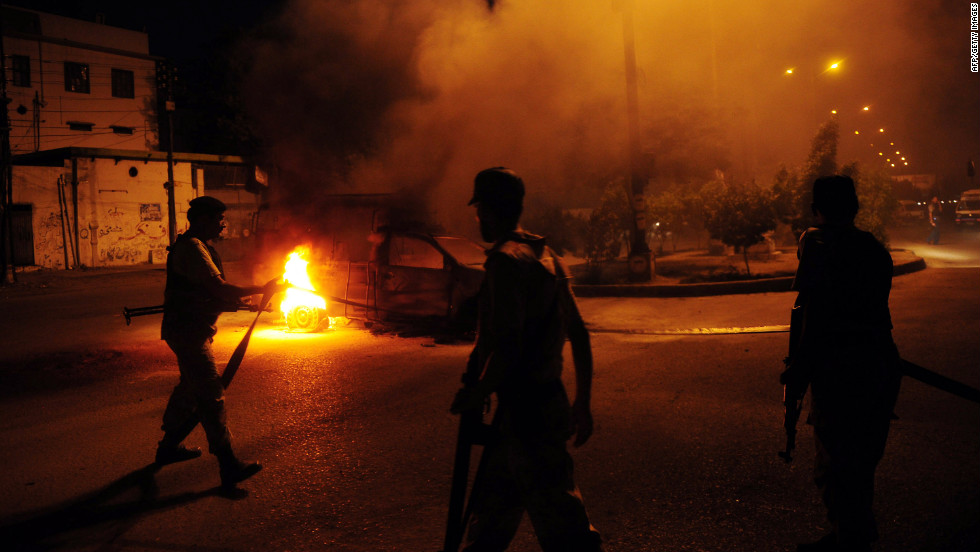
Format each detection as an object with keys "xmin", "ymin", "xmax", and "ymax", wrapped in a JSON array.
[{"xmin": 160, "ymin": 234, "xmax": 231, "ymax": 454}]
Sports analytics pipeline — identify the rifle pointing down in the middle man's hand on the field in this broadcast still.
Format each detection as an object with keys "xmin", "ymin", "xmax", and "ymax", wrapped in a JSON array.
[{"xmin": 442, "ymin": 362, "xmax": 494, "ymax": 552}]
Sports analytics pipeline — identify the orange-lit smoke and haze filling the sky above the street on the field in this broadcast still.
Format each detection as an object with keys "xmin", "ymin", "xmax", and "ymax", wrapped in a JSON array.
[{"xmin": 239, "ymin": 0, "xmax": 980, "ymax": 233}]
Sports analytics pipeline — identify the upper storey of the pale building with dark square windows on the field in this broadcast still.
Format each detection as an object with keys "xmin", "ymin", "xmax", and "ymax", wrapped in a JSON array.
[{"xmin": 2, "ymin": 6, "xmax": 160, "ymax": 155}]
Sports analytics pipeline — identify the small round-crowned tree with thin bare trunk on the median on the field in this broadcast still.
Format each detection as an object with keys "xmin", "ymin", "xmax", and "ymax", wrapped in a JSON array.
[{"xmin": 704, "ymin": 185, "xmax": 776, "ymax": 274}]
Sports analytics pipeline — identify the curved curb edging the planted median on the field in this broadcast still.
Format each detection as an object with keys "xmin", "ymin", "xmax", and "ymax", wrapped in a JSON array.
[{"xmin": 572, "ymin": 257, "xmax": 926, "ymax": 297}]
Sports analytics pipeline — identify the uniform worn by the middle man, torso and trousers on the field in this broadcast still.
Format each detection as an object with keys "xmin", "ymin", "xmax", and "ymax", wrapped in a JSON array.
[{"xmin": 465, "ymin": 231, "xmax": 601, "ymax": 552}]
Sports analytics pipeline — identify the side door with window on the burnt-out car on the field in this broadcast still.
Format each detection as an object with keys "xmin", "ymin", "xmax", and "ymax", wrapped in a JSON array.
[{"xmin": 376, "ymin": 234, "xmax": 453, "ymax": 319}]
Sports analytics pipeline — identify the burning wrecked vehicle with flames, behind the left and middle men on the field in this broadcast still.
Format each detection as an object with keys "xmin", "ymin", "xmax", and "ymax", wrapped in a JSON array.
[{"xmin": 252, "ymin": 196, "xmax": 486, "ymax": 334}]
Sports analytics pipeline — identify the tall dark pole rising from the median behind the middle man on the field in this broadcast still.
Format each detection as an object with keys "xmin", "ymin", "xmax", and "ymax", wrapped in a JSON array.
[{"xmin": 622, "ymin": 0, "xmax": 653, "ymax": 282}]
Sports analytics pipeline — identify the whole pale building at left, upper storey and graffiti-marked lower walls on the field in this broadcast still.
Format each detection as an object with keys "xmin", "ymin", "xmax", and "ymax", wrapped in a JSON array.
[{"xmin": 0, "ymin": 6, "xmax": 266, "ymax": 269}]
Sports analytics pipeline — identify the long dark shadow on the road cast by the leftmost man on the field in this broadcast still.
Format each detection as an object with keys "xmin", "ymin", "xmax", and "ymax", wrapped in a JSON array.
[{"xmin": 0, "ymin": 464, "xmax": 247, "ymax": 551}]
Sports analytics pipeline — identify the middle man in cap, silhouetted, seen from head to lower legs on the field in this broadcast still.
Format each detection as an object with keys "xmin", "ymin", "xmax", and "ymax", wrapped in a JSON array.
[{"xmin": 451, "ymin": 167, "xmax": 602, "ymax": 552}]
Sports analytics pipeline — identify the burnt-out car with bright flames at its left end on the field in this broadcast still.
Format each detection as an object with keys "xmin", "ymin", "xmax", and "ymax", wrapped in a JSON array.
[{"xmin": 246, "ymin": 194, "xmax": 486, "ymax": 334}]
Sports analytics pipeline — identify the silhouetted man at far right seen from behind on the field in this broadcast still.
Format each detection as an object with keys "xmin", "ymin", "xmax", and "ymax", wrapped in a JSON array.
[{"xmin": 781, "ymin": 176, "xmax": 901, "ymax": 552}]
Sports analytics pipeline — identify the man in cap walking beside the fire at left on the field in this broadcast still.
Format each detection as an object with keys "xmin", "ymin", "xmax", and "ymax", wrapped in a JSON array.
[{"xmin": 156, "ymin": 196, "xmax": 278, "ymax": 489}]
